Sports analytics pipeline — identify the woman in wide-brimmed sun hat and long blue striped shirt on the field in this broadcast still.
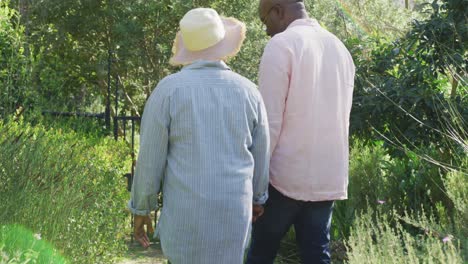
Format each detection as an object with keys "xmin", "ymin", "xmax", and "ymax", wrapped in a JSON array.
[{"xmin": 129, "ymin": 8, "xmax": 269, "ymax": 264}]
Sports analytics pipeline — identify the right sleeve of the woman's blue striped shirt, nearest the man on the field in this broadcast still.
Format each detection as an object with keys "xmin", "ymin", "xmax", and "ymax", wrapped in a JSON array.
[{"xmin": 250, "ymin": 98, "xmax": 270, "ymax": 204}]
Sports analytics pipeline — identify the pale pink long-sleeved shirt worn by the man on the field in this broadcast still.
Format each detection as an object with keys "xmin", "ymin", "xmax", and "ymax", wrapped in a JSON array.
[{"xmin": 259, "ymin": 19, "xmax": 355, "ymax": 201}]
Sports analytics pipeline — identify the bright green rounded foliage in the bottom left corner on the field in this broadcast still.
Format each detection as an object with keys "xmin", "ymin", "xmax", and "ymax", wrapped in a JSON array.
[{"xmin": 0, "ymin": 225, "xmax": 67, "ymax": 264}]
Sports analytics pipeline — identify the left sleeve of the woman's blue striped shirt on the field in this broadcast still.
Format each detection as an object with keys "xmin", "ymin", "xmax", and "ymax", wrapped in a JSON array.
[{"xmin": 128, "ymin": 85, "xmax": 170, "ymax": 215}]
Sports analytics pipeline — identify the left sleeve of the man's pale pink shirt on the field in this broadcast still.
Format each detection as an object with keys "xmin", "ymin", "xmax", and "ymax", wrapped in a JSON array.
[{"xmin": 259, "ymin": 38, "xmax": 291, "ymax": 153}]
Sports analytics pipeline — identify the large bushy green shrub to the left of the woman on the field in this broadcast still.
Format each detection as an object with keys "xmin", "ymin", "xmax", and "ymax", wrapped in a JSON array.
[{"xmin": 0, "ymin": 120, "xmax": 129, "ymax": 263}]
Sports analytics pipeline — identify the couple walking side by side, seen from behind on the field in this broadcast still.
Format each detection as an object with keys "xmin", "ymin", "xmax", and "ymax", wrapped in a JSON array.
[{"xmin": 129, "ymin": 0, "xmax": 354, "ymax": 264}]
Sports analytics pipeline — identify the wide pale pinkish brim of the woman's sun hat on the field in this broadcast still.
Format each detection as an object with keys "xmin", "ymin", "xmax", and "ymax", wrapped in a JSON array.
[{"xmin": 169, "ymin": 17, "xmax": 246, "ymax": 66}]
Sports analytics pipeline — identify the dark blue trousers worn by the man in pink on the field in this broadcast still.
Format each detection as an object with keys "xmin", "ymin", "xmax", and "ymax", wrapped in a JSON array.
[{"xmin": 246, "ymin": 185, "xmax": 334, "ymax": 264}]
